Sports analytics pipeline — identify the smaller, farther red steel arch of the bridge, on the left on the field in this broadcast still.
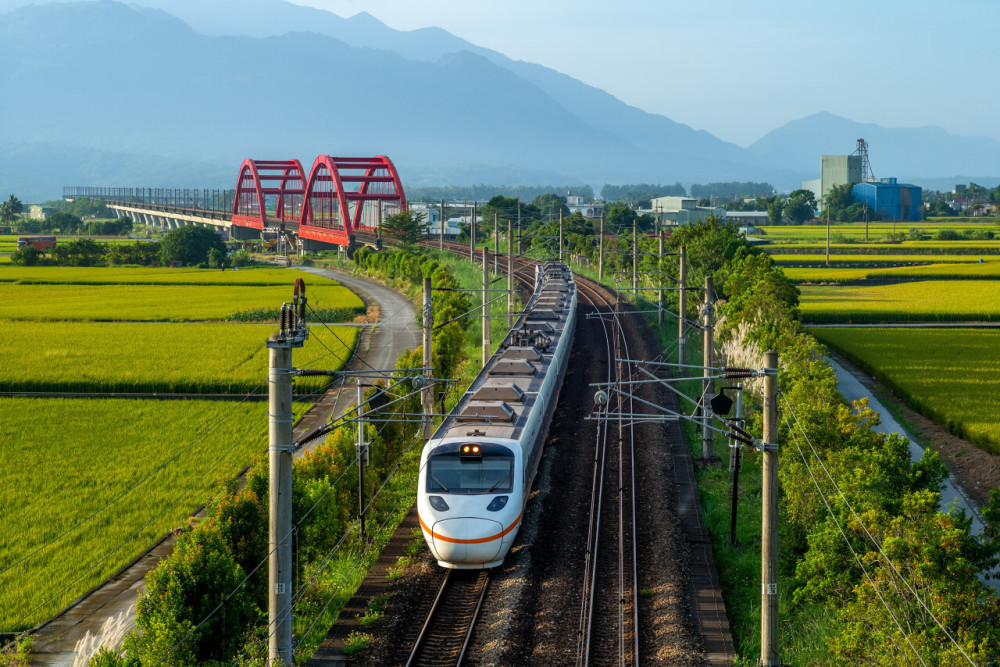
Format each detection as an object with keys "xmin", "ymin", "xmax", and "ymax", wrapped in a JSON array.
[{"xmin": 233, "ymin": 159, "xmax": 306, "ymax": 231}]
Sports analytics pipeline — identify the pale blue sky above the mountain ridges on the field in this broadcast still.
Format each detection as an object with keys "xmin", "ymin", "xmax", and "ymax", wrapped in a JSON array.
[{"xmin": 293, "ymin": 0, "xmax": 1000, "ymax": 145}]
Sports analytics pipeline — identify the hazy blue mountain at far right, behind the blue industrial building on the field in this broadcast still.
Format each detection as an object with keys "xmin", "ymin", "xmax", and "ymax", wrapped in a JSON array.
[{"xmin": 749, "ymin": 112, "xmax": 1000, "ymax": 181}]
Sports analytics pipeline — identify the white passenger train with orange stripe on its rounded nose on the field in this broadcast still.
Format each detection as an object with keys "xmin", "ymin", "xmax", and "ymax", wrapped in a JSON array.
[{"xmin": 417, "ymin": 263, "xmax": 576, "ymax": 569}]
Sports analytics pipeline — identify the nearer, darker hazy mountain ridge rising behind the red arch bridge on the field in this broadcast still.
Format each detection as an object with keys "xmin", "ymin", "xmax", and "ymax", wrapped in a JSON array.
[{"xmin": 0, "ymin": 0, "xmax": 787, "ymax": 201}]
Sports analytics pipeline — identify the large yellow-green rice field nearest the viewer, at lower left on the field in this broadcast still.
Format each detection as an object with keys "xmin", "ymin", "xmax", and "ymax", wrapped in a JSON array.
[{"xmin": 0, "ymin": 398, "xmax": 305, "ymax": 632}]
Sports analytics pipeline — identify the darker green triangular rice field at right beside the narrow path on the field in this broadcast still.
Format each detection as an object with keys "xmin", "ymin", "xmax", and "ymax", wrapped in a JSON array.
[{"xmin": 810, "ymin": 327, "xmax": 1000, "ymax": 454}]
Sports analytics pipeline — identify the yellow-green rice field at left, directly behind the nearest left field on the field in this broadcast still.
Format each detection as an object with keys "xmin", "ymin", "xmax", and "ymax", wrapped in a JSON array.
[{"xmin": 0, "ymin": 322, "xmax": 358, "ymax": 394}]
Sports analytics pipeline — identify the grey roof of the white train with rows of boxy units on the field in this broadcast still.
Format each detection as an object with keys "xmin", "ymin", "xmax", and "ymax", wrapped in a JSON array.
[{"xmin": 433, "ymin": 263, "xmax": 576, "ymax": 440}]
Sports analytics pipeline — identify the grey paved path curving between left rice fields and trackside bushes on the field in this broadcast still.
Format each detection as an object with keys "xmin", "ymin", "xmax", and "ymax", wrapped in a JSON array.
[{"xmin": 30, "ymin": 267, "xmax": 420, "ymax": 667}]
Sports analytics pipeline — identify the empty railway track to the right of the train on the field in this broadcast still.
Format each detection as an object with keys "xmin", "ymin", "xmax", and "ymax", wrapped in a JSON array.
[{"xmin": 576, "ymin": 277, "xmax": 639, "ymax": 665}]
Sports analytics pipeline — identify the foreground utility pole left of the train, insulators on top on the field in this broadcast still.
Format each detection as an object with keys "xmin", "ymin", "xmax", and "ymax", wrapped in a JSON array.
[{"xmin": 267, "ymin": 298, "xmax": 306, "ymax": 665}]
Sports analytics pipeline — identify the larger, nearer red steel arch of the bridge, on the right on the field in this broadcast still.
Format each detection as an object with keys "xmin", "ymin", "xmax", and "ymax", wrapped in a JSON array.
[{"xmin": 299, "ymin": 155, "xmax": 407, "ymax": 246}]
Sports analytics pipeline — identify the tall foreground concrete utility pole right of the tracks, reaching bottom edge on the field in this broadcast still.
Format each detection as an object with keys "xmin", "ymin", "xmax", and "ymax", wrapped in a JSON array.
[{"xmin": 760, "ymin": 351, "xmax": 781, "ymax": 667}]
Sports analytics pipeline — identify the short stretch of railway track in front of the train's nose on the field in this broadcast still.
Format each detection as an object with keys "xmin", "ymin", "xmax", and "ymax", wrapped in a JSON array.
[{"xmin": 406, "ymin": 570, "xmax": 490, "ymax": 667}]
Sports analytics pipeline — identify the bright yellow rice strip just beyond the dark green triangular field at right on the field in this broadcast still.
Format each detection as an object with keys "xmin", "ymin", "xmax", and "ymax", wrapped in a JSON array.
[{"xmin": 799, "ymin": 280, "xmax": 1000, "ymax": 324}]
